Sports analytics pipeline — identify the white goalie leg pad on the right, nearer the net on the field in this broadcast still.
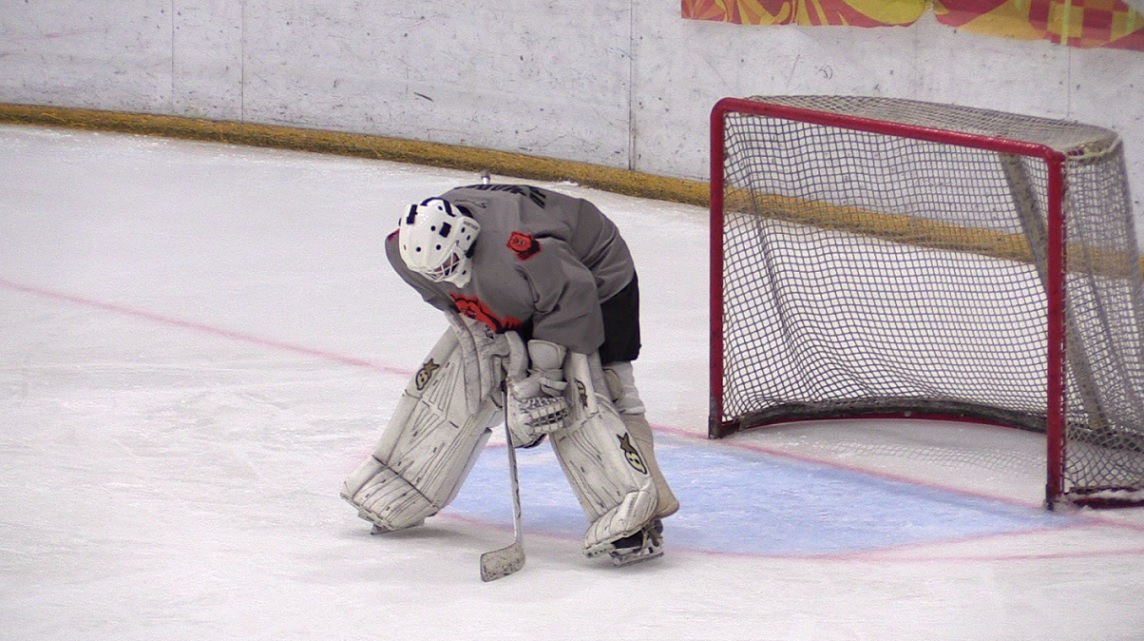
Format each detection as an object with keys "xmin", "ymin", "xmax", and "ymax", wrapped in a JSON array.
[{"xmin": 551, "ymin": 353, "xmax": 658, "ymax": 556}]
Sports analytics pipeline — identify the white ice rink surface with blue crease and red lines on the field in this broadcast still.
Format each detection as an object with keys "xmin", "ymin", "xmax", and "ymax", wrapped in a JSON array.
[{"xmin": 0, "ymin": 126, "xmax": 1144, "ymax": 641}]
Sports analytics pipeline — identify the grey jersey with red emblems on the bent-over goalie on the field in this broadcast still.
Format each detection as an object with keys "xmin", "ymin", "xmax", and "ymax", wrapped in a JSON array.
[{"xmin": 386, "ymin": 184, "xmax": 635, "ymax": 354}]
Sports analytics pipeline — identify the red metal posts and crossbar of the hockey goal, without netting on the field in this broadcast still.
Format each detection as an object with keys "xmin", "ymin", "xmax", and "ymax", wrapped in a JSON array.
[{"xmin": 708, "ymin": 97, "xmax": 1067, "ymax": 509}]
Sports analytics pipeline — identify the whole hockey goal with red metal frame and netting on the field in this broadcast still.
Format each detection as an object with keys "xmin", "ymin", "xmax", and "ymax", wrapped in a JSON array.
[{"xmin": 709, "ymin": 96, "xmax": 1144, "ymax": 508}]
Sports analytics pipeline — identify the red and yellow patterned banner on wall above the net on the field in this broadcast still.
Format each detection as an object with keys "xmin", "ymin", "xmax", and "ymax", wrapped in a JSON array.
[{"xmin": 682, "ymin": 0, "xmax": 1144, "ymax": 52}]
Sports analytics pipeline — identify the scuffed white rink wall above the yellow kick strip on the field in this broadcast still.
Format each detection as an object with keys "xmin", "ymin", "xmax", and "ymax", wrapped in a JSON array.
[{"xmin": 0, "ymin": 0, "xmax": 1144, "ymax": 215}]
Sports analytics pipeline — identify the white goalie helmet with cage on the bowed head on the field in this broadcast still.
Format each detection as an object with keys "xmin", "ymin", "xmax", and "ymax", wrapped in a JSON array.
[{"xmin": 397, "ymin": 198, "xmax": 480, "ymax": 287}]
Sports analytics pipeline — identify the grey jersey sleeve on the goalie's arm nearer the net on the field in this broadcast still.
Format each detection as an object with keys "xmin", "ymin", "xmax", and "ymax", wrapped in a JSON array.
[{"xmin": 521, "ymin": 238, "xmax": 604, "ymax": 354}]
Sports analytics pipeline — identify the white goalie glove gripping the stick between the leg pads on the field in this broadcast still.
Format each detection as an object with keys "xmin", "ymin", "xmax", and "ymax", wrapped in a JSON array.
[{"xmin": 507, "ymin": 340, "xmax": 569, "ymax": 448}]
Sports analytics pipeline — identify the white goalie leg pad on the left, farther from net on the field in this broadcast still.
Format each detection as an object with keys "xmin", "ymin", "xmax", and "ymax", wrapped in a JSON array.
[{"xmin": 341, "ymin": 318, "xmax": 508, "ymax": 531}]
